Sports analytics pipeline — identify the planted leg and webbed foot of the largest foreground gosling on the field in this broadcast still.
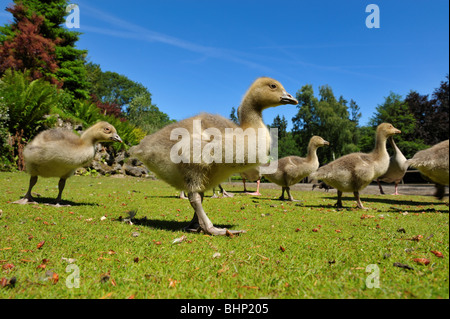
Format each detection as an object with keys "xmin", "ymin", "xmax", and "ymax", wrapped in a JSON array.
[{"xmin": 185, "ymin": 192, "xmax": 244, "ymax": 235}]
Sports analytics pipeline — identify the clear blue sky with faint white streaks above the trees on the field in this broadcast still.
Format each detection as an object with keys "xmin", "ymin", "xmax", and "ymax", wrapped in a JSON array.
[{"xmin": 0, "ymin": 0, "xmax": 449, "ymax": 129}]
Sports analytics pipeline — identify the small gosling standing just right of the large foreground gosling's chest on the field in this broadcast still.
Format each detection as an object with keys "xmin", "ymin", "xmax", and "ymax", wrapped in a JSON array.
[{"xmin": 263, "ymin": 136, "xmax": 330, "ymax": 201}]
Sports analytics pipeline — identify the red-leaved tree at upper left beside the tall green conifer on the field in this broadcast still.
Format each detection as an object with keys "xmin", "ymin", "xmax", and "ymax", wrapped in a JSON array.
[{"xmin": 0, "ymin": 5, "xmax": 62, "ymax": 86}]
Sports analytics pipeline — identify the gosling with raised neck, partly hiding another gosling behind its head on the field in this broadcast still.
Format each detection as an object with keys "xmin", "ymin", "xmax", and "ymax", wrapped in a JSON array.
[{"xmin": 310, "ymin": 123, "xmax": 401, "ymax": 209}]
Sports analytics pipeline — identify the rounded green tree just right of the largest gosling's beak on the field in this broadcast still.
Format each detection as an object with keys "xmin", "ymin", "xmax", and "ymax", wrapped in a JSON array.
[{"xmin": 292, "ymin": 85, "xmax": 357, "ymax": 163}]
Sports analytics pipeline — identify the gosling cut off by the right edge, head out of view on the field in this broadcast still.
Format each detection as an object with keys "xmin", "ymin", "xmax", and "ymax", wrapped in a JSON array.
[{"xmin": 407, "ymin": 140, "xmax": 449, "ymax": 199}]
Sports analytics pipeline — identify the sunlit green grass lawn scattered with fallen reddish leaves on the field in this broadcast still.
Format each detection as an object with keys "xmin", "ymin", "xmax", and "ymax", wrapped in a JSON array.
[{"xmin": 0, "ymin": 173, "xmax": 449, "ymax": 299}]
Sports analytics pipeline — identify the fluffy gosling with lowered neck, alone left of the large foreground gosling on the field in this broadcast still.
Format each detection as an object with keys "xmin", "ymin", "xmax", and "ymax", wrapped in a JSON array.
[{"xmin": 14, "ymin": 122, "xmax": 122, "ymax": 206}]
